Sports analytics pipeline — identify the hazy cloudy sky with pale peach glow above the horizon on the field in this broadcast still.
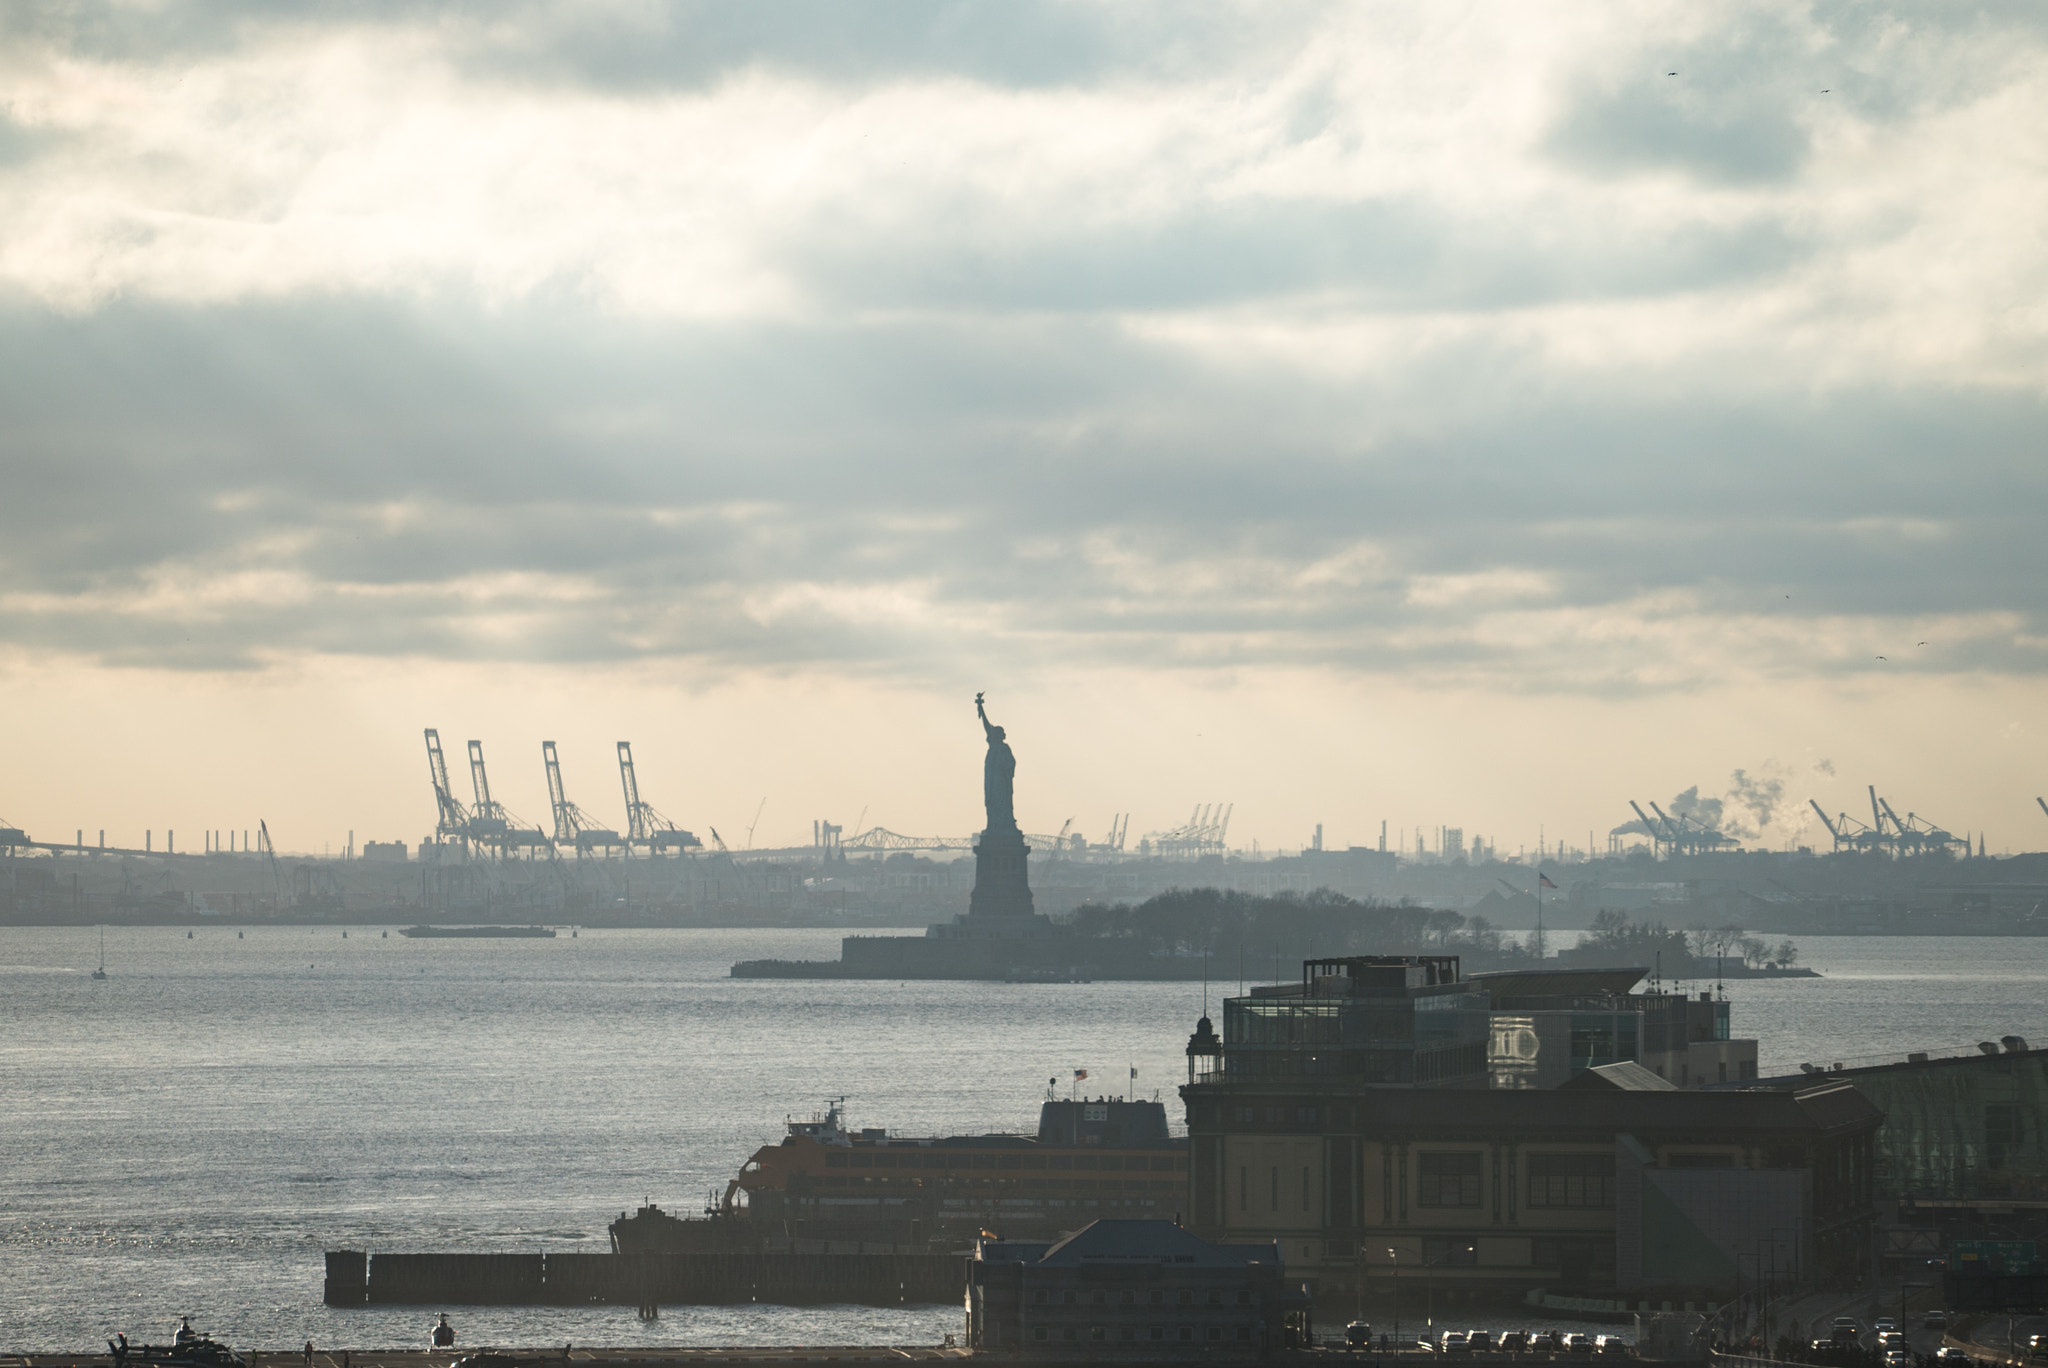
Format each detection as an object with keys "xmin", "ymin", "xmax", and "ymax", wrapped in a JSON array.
[{"xmin": 0, "ymin": 0, "xmax": 2048, "ymax": 850}]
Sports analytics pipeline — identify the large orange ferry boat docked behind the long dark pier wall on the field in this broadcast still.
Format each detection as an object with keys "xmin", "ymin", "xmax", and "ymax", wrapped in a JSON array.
[{"xmin": 612, "ymin": 1098, "xmax": 1188, "ymax": 1253}]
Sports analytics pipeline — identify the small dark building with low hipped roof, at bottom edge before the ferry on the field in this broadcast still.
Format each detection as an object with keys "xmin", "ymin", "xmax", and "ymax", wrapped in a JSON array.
[{"xmin": 967, "ymin": 1221, "xmax": 1309, "ymax": 1362}]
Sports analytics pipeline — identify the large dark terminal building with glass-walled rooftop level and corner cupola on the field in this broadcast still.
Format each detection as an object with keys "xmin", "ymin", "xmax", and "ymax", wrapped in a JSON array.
[{"xmin": 1182, "ymin": 960, "xmax": 1880, "ymax": 1296}]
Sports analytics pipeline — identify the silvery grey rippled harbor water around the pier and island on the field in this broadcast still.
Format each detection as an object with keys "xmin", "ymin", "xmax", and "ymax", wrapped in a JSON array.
[{"xmin": 0, "ymin": 928, "xmax": 2048, "ymax": 1352}]
